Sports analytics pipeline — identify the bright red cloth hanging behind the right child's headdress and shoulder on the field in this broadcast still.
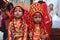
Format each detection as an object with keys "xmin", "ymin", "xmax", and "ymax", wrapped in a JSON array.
[{"xmin": 41, "ymin": 3, "xmax": 52, "ymax": 34}]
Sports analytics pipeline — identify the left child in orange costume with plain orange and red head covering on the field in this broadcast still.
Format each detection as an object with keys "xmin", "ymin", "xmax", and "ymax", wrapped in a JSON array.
[{"xmin": 8, "ymin": 5, "xmax": 28, "ymax": 40}]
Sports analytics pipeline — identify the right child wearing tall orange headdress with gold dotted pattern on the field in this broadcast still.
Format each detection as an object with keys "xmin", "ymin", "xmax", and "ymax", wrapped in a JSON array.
[{"xmin": 29, "ymin": 3, "xmax": 48, "ymax": 40}]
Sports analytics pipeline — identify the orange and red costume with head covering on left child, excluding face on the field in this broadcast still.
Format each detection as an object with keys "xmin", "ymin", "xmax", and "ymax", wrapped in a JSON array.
[{"xmin": 8, "ymin": 5, "xmax": 28, "ymax": 40}]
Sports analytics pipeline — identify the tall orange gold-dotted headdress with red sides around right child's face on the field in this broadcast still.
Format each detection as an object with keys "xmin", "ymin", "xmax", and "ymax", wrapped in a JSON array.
[{"xmin": 29, "ymin": 3, "xmax": 44, "ymax": 29}]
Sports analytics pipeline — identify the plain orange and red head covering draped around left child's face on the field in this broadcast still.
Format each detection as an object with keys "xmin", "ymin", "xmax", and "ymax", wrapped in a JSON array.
[{"xmin": 10, "ymin": 4, "xmax": 29, "ymax": 20}]
